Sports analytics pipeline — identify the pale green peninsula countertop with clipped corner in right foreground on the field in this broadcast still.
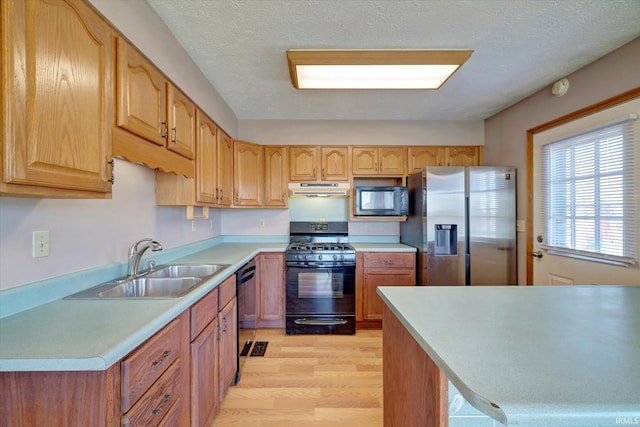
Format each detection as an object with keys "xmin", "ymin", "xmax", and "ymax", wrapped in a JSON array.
[{"xmin": 378, "ymin": 286, "xmax": 640, "ymax": 427}]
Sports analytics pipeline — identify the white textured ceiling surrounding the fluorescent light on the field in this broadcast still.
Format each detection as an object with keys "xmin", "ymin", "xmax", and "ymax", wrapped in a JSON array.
[{"xmin": 147, "ymin": 0, "xmax": 640, "ymax": 120}]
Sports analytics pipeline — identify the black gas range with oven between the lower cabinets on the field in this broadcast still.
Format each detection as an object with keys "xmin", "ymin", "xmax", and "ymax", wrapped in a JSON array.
[{"xmin": 285, "ymin": 222, "xmax": 356, "ymax": 335}]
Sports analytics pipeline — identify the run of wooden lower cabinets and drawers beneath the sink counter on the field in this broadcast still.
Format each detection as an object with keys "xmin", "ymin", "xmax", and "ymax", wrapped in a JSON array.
[{"xmin": 0, "ymin": 275, "xmax": 238, "ymax": 427}]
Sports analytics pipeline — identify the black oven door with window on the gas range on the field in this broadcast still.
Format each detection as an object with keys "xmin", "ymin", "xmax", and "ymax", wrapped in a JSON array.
[{"xmin": 286, "ymin": 266, "xmax": 356, "ymax": 316}]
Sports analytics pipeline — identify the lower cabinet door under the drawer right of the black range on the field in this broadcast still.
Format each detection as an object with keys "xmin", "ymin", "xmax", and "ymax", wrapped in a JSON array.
[{"xmin": 363, "ymin": 269, "xmax": 415, "ymax": 320}]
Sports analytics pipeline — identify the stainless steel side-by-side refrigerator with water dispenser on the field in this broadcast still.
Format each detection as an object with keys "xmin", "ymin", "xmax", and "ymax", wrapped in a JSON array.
[{"xmin": 400, "ymin": 166, "xmax": 517, "ymax": 286}]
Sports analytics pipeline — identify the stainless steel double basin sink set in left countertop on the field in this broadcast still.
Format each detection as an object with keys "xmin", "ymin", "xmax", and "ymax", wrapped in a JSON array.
[{"xmin": 68, "ymin": 264, "xmax": 229, "ymax": 299}]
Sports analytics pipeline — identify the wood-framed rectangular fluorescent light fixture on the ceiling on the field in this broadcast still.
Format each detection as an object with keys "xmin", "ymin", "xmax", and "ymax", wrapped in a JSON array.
[{"xmin": 287, "ymin": 49, "xmax": 472, "ymax": 89}]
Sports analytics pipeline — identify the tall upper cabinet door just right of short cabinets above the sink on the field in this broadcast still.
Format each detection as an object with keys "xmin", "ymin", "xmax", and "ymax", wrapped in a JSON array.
[{"xmin": 196, "ymin": 110, "xmax": 218, "ymax": 204}]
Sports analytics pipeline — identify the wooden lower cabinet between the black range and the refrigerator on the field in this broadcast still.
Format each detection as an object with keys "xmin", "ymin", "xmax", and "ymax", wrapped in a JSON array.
[{"xmin": 356, "ymin": 252, "xmax": 416, "ymax": 328}]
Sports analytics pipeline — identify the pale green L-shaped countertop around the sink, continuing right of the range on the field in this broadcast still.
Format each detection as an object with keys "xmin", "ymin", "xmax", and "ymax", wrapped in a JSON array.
[{"xmin": 0, "ymin": 242, "xmax": 414, "ymax": 371}]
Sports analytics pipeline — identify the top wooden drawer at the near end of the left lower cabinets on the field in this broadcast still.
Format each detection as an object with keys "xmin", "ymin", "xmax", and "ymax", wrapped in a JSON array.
[{"xmin": 120, "ymin": 318, "xmax": 181, "ymax": 412}]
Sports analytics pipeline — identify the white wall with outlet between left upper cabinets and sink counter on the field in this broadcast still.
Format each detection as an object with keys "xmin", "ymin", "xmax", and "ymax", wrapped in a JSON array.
[{"xmin": 0, "ymin": 159, "xmax": 222, "ymax": 290}]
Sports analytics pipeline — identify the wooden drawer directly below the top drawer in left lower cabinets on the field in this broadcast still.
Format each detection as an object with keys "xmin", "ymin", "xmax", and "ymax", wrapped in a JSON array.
[{"xmin": 122, "ymin": 360, "xmax": 181, "ymax": 427}]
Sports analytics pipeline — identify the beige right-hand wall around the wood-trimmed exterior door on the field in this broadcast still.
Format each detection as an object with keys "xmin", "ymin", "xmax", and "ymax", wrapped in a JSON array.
[{"xmin": 484, "ymin": 38, "xmax": 640, "ymax": 284}]
